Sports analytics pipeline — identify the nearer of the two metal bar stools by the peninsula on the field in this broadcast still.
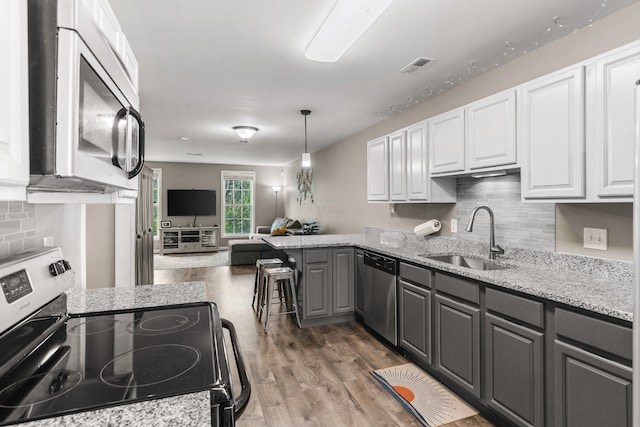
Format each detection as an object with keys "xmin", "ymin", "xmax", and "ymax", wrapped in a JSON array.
[{"xmin": 260, "ymin": 267, "xmax": 302, "ymax": 334}]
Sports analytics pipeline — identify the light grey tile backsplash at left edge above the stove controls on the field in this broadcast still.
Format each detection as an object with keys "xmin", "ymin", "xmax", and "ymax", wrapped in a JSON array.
[{"xmin": 0, "ymin": 201, "xmax": 36, "ymax": 257}]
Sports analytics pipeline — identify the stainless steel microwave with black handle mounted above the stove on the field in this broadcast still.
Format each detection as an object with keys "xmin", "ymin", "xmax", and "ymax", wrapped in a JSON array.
[{"xmin": 28, "ymin": 0, "xmax": 145, "ymax": 193}]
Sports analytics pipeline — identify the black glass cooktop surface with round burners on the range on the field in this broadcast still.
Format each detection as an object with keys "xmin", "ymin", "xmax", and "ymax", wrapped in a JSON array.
[{"xmin": 0, "ymin": 303, "xmax": 220, "ymax": 425}]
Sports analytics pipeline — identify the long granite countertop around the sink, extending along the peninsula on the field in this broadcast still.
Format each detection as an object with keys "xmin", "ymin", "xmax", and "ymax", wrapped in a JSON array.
[{"xmin": 263, "ymin": 228, "xmax": 633, "ymax": 321}]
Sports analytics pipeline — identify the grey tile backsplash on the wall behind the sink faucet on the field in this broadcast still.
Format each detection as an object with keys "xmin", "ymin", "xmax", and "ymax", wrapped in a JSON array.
[{"xmin": 455, "ymin": 174, "xmax": 556, "ymax": 251}]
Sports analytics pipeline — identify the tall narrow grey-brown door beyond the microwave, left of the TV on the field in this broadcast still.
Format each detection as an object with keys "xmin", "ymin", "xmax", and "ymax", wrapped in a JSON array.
[{"xmin": 136, "ymin": 167, "xmax": 153, "ymax": 285}]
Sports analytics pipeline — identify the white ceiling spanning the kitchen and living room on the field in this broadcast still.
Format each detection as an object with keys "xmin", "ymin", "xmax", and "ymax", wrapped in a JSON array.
[{"xmin": 110, "ymin": 0, "xmax": 637, "ymax": 166}]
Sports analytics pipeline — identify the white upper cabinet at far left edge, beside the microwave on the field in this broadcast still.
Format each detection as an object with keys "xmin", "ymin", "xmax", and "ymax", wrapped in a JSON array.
[{"xmin": 0, "ymin": 0, "xmax": 29, "ymax": 200}]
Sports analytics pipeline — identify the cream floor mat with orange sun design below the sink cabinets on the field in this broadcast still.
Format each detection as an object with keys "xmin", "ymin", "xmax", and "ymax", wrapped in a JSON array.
[{"xmin": 371, "ymin": 363, "xmax": 478, "ymax": 427}]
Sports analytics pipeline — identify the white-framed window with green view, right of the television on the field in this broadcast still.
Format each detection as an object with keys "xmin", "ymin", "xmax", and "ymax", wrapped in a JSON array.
[{"xmin": 222, "ymin": 171, "xmax": 256, "ymax": 237}]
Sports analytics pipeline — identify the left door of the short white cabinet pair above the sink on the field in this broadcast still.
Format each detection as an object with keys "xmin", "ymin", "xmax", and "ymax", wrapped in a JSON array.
[{"xmin": 428, "ymin": 108, "xmax": 464, "ymax": 174}]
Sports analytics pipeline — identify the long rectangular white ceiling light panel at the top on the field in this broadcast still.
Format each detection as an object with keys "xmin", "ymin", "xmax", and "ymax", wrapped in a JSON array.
[{"xmin": 304, "ymin": 0, "xmax": 393, "ymax": 62}]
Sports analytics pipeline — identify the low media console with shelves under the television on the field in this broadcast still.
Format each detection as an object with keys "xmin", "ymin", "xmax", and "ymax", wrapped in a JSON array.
[{"xmin": 160, "ymin": 227, "xmax": 220, "ymax": 255}]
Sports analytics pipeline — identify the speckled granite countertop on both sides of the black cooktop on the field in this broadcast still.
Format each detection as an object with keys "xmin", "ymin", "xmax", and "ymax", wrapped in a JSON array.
[{"xmin": 20, "ymin": 282, "xmax": 211, "ymax": 427}]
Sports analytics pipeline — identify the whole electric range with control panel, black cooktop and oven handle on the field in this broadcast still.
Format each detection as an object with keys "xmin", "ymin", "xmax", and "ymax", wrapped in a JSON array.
[{"xmin": 0, "ymin": 248, "xmax": 251, "ymax": 426}]
